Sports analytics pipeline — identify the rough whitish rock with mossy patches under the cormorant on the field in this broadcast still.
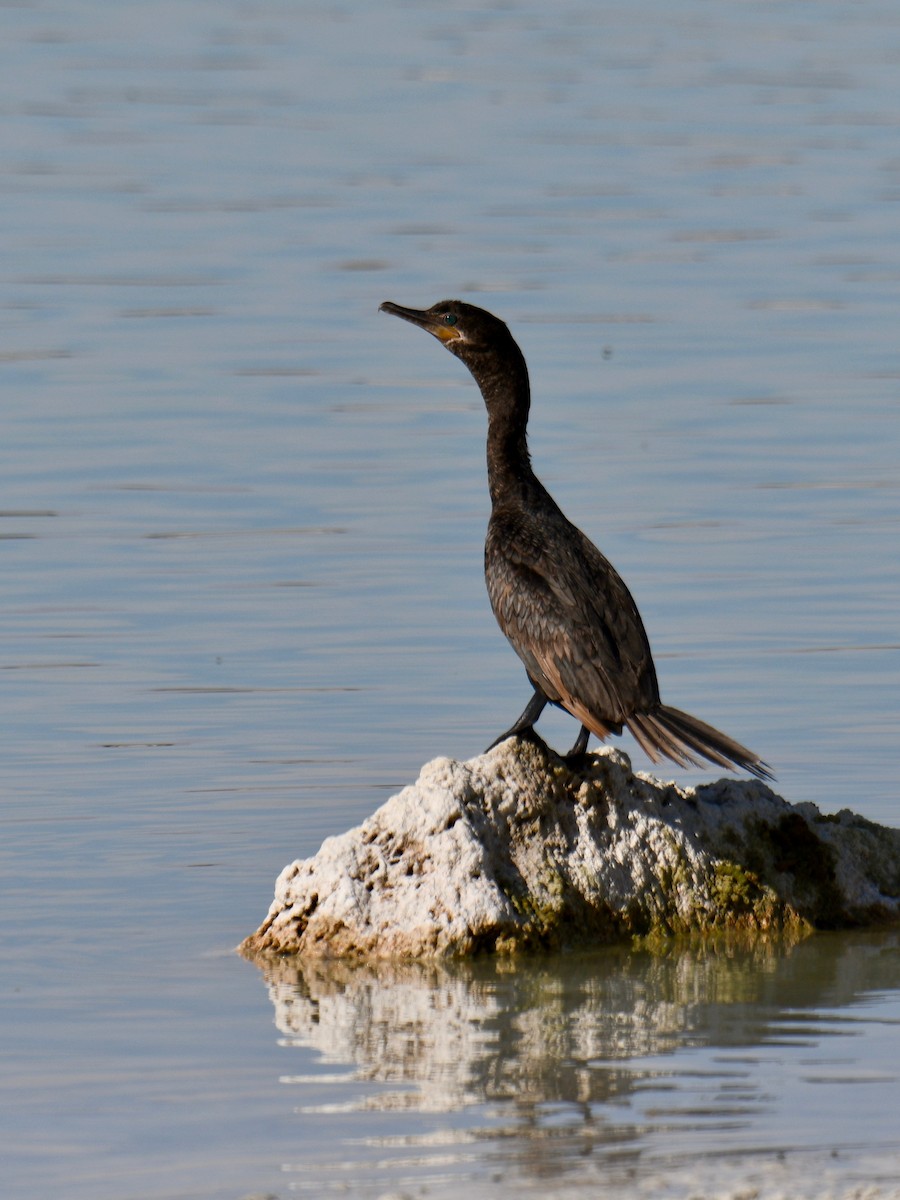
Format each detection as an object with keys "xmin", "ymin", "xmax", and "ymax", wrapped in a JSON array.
[{"xmin": 244, "ymin": 739, "xmax": 900, "ymax": 958}]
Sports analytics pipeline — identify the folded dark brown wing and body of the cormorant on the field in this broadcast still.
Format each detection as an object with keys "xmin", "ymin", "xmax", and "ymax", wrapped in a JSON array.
[{"xmin": 485, "ymin": 501, "xmax": 659, "ymax": 736}]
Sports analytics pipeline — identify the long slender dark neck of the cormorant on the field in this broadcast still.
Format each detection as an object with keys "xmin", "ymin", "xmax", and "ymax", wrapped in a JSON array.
[{"xmin": 469, "ymin": 347, "xmax": 535, "ymax": 504}]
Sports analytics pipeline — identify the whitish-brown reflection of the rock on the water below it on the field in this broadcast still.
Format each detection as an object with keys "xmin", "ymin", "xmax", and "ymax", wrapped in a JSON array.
[{"xmin": 256, "ymin": 934, "xmax": 900, "ymax": 1111}]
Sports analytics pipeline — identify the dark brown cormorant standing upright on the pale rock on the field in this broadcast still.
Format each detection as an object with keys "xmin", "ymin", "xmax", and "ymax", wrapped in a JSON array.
[{"xmin": 379, "ymin": 300, "xmax": 774, "ymax": 780}]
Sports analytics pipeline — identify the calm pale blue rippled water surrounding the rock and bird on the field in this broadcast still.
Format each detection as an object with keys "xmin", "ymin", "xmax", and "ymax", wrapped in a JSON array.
[{"xmin": 0, "ymin": 0, "xmax": 900, "ymax": 1200}]
